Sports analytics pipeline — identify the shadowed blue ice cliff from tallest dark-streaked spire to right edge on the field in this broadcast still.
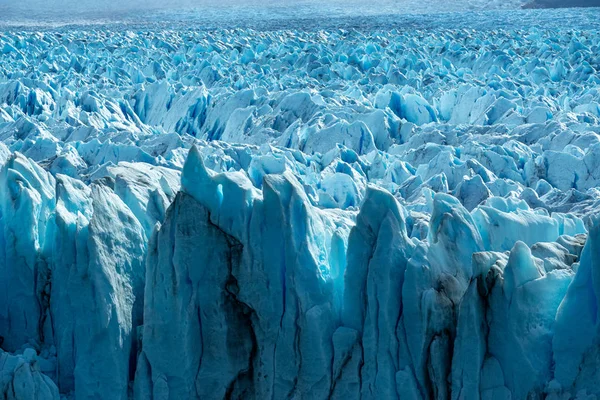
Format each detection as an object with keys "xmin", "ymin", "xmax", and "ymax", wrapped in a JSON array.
[{"xmin": 131, "ymin": 149, "xmax": 598, "ymax": 398}]
